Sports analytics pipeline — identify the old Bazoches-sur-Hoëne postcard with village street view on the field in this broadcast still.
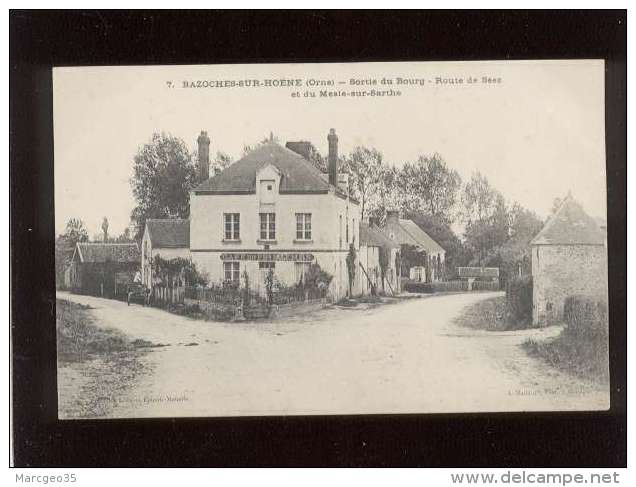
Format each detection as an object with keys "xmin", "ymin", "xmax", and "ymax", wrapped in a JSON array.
[{"xmin": 53, "ymin": 60, "xmax": 609, "ymax": 419}]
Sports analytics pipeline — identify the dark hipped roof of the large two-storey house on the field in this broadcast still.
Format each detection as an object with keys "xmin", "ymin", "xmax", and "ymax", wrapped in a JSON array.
[{"xmin": 194, "ymin": 141, "xmax": 329, "ymax": 194}]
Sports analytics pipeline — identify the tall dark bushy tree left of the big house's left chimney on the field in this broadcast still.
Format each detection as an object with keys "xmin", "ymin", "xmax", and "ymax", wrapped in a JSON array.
[{"xmin": 130, "ymin": 133, "xmax": 197, "ymax": 240}]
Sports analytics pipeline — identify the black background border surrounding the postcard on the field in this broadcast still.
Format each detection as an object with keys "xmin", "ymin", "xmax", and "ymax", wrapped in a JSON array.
[{"xmin": 9, "ymin": 10, "xmax": 627, "ymax": 467}]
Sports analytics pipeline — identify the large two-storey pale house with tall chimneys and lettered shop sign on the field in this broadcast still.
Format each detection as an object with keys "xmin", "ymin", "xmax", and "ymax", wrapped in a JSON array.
[{"xmin": 186, "ymin": 129, "xmax": 361, "ymax": 299}]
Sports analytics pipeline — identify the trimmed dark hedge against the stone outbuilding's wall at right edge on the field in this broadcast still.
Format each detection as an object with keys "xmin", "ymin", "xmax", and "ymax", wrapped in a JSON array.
[{"xmin": 563, "ymin": 295, "xmax": 608, "ymax": 337}]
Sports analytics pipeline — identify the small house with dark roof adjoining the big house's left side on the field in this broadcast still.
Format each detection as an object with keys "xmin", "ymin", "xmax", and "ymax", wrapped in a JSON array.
[{"xmin": 141, "ymin": 219, "xmax": 191, "ymax": 288}]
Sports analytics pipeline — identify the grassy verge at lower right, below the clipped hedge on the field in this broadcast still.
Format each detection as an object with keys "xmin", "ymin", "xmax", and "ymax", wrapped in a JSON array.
[{"xmin": 522, "ymin": 327, "xmax": 609, "ymax": 384}]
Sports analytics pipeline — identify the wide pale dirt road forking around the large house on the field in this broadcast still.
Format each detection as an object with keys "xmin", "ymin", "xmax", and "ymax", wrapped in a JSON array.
[{"xmin": 58, "ymin": 293, "xmax": 609, "ymax": 417}]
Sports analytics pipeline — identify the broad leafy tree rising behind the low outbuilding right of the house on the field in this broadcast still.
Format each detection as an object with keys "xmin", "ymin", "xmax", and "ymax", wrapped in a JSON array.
[{"xmin": 399, "ymin": 153, "xmax": 461, "ymax": 223}]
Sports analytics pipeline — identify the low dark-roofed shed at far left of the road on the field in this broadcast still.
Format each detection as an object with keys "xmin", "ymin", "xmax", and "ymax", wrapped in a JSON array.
[{"xmin": 66, "ymin": 242, "xmax": 140, "ymax": 298}]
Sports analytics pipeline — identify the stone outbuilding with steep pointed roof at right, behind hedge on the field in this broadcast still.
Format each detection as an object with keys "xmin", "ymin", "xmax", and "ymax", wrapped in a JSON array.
[{"xmin": 530, "ymin": 195, "xmax": 607, "ymax": 324}]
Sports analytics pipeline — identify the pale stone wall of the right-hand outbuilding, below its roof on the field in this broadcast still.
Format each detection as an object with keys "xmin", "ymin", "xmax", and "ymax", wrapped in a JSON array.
[{"xmin": 532, "ymin": 245, "xmax": 607, "ymax": 325}]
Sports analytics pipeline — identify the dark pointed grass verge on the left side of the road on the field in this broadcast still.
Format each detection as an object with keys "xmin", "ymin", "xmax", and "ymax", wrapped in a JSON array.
[{"xmin": 55, "ymin": 299, "xmax": 163, "ymax": 365}]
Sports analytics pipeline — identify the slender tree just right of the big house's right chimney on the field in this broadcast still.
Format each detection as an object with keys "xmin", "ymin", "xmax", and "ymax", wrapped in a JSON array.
[{"xmin": 345, "ymin": 147, "xmax": 383, "ymax": 218}]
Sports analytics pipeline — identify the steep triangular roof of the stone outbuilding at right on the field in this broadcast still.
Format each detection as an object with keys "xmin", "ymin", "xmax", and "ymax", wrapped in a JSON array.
[{"xmin": 530, "ymin": 196, "xmax": 605, "ymax": 245}]
